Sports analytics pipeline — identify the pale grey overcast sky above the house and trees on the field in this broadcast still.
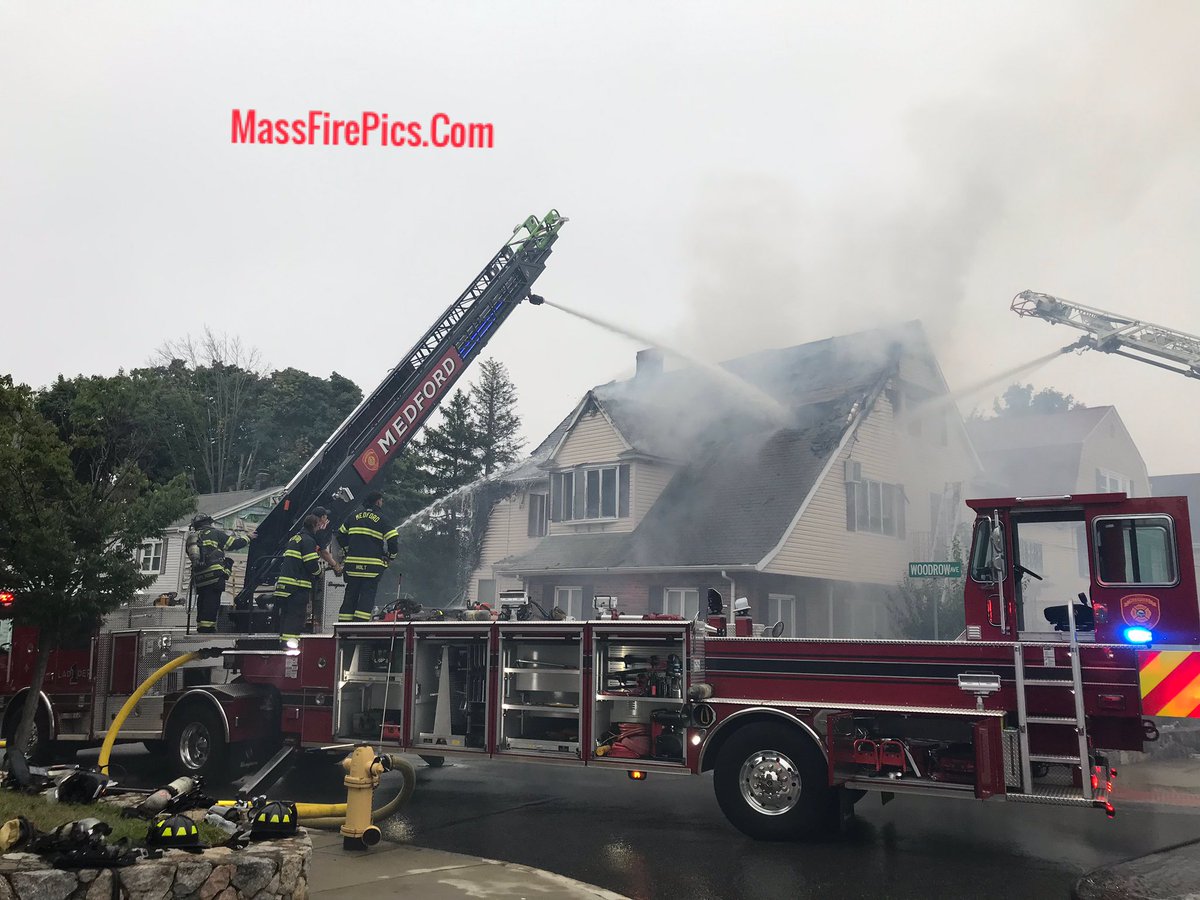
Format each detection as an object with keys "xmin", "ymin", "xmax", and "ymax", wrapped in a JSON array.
[{"xmin": 0, "ymin": 0, "xmax": 1200, "ymax": 474}]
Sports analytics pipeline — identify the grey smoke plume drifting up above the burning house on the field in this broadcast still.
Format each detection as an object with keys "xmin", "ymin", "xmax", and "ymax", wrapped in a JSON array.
[{"xmin": 678, "ymin": 4, "xmax": 1200, "ymax": 376}]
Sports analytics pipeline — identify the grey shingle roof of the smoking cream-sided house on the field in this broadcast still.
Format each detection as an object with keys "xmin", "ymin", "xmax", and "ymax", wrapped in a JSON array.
[{"xmin": 498, "ymin": 324, "xmax": 928, "ymax": 572}]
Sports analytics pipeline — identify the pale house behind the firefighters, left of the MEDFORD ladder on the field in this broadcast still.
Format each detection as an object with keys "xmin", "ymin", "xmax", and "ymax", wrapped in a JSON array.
[{"xmin": 137, "ymin": 487, "xmax": 286, "ymax": 600}]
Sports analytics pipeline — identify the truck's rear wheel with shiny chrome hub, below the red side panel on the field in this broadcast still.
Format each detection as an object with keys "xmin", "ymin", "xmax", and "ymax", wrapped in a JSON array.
[{"xmin": 713, "ymin": 722, "xmax": 838, "ymax": 841}]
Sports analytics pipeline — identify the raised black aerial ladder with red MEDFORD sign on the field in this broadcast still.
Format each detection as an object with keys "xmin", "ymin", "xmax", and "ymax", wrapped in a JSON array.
[{"xmin": 234, "ymin": 210, "xmax": 566, "ymax": 611}]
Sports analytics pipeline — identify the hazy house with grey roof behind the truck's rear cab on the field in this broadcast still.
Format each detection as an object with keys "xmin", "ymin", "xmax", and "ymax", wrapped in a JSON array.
[{"xmin": 967, "ymin": 407, "xmax": 1150, "ymax": 640}]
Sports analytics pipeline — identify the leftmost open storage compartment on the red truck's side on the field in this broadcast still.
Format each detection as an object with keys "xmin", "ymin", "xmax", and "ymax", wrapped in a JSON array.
[{"xmin": 335, "ymin": 635, "xmax": 404, "ymax": 744}]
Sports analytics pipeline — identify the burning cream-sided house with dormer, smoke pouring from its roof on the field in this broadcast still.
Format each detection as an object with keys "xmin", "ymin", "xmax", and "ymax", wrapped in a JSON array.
[{"xmin": 473, "ymin": 323, "xmax": 979, "ymax": 637}]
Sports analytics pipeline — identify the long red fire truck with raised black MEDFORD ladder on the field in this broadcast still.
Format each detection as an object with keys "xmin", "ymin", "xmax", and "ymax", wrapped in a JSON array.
[{"xmin": 0, "ymin": 212, "xmax": 1200, "ymax": 839}]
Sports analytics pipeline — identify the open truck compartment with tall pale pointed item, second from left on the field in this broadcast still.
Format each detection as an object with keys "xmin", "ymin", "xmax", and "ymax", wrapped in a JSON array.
[{"xmin": 413, "ymin": 634, "xmax": 487, "ymax": 750}]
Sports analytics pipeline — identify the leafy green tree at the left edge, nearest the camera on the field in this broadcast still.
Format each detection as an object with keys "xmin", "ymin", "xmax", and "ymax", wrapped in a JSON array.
[{"xmin": 0, "ymin": 376, "xmax": 194, "ymax": 746}]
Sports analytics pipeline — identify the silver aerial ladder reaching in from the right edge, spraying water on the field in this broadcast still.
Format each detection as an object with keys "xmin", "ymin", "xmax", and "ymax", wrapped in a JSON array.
[{"xmin": 1010, "ymin": 290, "xmax": 1200, "ymax": 378}]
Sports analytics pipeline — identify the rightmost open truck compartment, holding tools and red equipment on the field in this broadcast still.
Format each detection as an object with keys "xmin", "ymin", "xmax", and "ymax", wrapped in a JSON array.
[{"xmin": 593, "ymin": 629, "xmax": 689, "ymax": 766}]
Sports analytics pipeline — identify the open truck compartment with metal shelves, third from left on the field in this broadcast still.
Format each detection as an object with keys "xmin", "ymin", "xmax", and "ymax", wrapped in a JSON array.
[{"xmin": 499, "ymin": 632, "xmax": 582, "ymax": 756}]
